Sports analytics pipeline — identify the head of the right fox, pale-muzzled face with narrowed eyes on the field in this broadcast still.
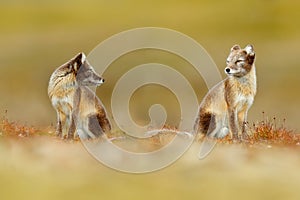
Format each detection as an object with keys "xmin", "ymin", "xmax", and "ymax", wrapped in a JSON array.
[{"xmin": 225, "ymin": 45, "xmax": 255, "ymax": 77}]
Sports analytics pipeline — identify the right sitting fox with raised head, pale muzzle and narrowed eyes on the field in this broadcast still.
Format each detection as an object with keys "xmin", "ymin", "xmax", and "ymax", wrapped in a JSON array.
[{"xmin": 196, "ymin": 45, "xmax": 256, "ymax": 140}]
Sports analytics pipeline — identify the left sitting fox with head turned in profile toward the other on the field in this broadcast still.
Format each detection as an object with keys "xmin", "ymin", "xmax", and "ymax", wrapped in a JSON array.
[{"xmin": 48, "ymin": 53, "xmax": 111, "ymax": 139}]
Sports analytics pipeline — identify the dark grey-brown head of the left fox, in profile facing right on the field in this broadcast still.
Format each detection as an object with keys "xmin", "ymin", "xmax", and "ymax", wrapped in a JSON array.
[{"xmin": 69, "ymin": 53, "xmax": 104, "ymax": 86}]
